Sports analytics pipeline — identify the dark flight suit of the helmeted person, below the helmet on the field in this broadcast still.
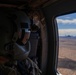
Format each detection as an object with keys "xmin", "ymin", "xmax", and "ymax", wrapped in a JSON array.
[{"xmin": 0, "ymin": 58, "xmax": 42, "ymax": 75}]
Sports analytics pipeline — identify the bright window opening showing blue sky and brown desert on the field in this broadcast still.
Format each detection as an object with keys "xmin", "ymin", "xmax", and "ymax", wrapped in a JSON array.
[{"xmin": 56, "ymin": 13, "xmax": 76, "ymax": 75}]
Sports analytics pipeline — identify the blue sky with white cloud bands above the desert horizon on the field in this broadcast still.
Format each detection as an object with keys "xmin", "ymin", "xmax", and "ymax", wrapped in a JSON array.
[{"xmin": 56, "ymin": 13, "xmax": 76, "ymax": 36}]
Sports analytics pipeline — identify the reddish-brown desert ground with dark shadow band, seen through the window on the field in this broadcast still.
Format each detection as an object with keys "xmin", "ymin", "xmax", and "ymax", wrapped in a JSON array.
[{"xmin": 58, "ymin": 37, "xmax": 76, "ymax": 75}]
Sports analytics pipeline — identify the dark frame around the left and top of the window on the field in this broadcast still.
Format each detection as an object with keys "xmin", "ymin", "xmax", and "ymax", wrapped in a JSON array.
[{"xmin": 42, "ymin": 0, "xmax": 76, "ymax": 75}]
